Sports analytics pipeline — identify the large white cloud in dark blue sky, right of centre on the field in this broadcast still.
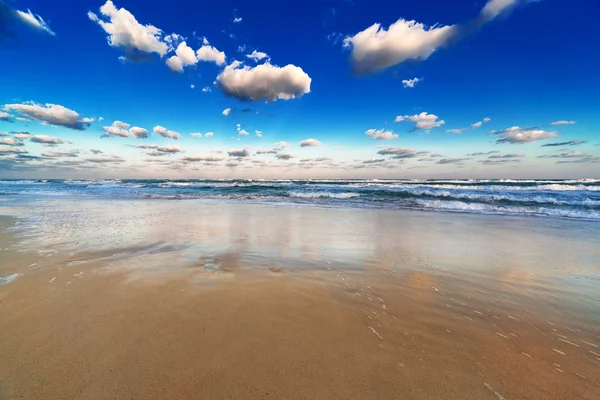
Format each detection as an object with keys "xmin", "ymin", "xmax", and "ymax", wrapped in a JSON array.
[{"xmin": 344, "ymin": 18, "xmax": 456, "ymax": 75}]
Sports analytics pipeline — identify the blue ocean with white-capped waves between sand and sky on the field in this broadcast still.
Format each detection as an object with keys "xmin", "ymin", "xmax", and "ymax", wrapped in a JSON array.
[{"xmin": 0, "ymin": 179, "xmax": 600, "ymax": 221}]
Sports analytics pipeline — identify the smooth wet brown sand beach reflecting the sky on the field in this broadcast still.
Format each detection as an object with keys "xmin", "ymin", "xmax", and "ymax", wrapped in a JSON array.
[{"xmin": 0, "ymin": 199, "xmax": 600, "ymax": 400}]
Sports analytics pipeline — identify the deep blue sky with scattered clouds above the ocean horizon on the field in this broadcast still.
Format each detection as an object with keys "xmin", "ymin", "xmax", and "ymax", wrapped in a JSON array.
[{"xmin": 0, "ymin": 0, "xmax": 600, "ymax": 179}]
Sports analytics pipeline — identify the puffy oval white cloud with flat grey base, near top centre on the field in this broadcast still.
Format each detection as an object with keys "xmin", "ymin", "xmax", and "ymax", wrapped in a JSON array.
[{"xmin": 217, "ymin": 61, "xmax": 311, "ymax": 102}]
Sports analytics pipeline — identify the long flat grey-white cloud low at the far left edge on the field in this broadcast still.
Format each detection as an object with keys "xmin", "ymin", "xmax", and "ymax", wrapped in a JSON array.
[{"xmin": 4, "ymin": 102, "xmax": 91, "ymax": 130}]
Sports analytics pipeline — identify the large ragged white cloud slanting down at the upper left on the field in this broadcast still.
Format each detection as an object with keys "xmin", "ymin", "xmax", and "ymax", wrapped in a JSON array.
[{"xmin": 88, "ymin": 0, "xmax": 170, "ymax": 60}]
